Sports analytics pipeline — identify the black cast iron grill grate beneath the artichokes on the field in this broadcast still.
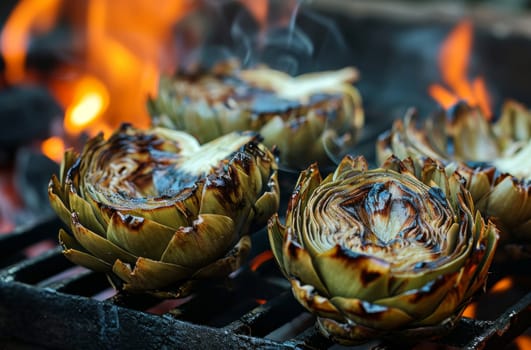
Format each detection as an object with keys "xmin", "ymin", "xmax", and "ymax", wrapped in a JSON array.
[{"xmin": 0, "ymin": 219, "xmax": 531, "ymax": 349}]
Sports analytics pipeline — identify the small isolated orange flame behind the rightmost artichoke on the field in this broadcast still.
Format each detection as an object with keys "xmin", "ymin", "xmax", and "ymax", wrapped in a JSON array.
[{"xmin": 428, "ymin": 20, "xmax": 492, "ymax": 119}]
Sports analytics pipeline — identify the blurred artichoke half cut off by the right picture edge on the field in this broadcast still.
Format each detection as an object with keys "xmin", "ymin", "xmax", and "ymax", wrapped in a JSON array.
[{"xmin": 377, "ymin": 101, "xmax": 531, "ymax": 249}]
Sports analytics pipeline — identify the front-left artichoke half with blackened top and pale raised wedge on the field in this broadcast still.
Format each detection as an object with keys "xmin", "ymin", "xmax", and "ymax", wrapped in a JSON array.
[{"xmin": 48, "ymin": 125, "xmax": 279, "ymax": 297}]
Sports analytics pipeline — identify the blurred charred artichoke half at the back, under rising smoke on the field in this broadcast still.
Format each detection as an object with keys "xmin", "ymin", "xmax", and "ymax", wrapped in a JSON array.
[{"xmin": 148, "ymin": 62, "xmax": 364, "ymax": 169}]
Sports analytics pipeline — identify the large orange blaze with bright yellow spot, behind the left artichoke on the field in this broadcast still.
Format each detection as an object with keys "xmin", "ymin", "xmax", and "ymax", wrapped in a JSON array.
[{"xmin": 0, "ymin": 0, "xmax": 199, "ymax": 157}]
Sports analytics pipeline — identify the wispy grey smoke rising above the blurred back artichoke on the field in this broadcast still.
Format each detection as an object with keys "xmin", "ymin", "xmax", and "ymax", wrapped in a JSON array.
[{"xmin": 176, "ymin": 0, "xmax": 351, "ymax": 75}]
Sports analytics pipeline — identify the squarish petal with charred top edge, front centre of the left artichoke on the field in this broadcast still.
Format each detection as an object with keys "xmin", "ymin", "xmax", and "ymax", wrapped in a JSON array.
[{"xmin": 107, "ymin": 212, "xmax": 175, "ymax": 260}]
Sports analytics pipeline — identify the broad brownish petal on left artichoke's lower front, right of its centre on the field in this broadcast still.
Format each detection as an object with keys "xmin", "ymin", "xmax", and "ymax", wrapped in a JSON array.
[{"xmin": 161, "ymin": 214, "xmax": 237, "ymax": 267}]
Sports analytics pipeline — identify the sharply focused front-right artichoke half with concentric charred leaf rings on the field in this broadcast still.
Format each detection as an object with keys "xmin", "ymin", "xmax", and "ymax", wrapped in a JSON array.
[{"xmin": 268, "ymin": 157, "xmax": 498, "ymax": 344}]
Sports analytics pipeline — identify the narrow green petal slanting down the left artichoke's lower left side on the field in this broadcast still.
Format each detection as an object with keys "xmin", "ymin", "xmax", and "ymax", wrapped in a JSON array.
[{"xmin": 71, "ymin": 213, "xmax": 136, "ymax": 264}]
